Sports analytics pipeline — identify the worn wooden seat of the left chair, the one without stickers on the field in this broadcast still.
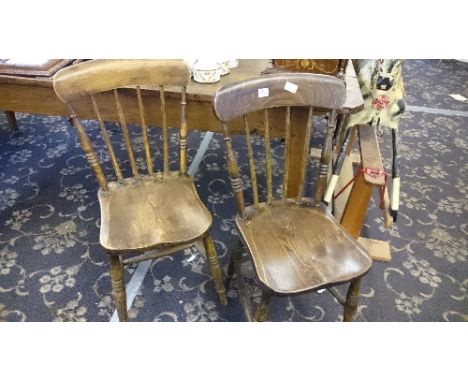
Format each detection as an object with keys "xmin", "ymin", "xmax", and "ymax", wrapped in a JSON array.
[{"xmin": 98, "ymin": 172, "xmax": 212, "ymax": 251}]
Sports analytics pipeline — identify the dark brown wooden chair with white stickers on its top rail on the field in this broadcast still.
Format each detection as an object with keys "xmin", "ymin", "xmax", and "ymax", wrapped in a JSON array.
[{"xmin": 214, "ymin": 73, "xmax": 372, "ymax": 321}]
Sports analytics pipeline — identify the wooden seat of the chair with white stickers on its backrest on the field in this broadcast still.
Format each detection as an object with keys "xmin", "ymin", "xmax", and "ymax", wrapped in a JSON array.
[{"xmin": 236, "ymin": 200, "xmax": 372, "ymax": 293}]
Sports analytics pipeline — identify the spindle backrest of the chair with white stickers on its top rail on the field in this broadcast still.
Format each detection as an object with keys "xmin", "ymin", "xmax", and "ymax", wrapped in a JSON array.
[{"xmin": 214, "ymin": 73, "xmax": 346, "ymax": 217}]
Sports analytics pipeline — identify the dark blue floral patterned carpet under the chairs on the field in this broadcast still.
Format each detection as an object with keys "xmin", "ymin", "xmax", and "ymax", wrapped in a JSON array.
[{"xmin": 0, "ymin": 60, "xmax": 468, "ymax": 321}]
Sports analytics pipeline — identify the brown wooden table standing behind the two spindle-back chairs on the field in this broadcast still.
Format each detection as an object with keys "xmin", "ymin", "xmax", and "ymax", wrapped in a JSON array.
[{"xmin": 0, "ymin": 60, "xmax": 363, "ymax": 196}]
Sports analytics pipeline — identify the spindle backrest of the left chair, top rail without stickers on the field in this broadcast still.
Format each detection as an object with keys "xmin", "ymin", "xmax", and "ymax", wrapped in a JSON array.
[{"xmin": 54, "ymin": 60, "xmax": 190, "ymax": 190}]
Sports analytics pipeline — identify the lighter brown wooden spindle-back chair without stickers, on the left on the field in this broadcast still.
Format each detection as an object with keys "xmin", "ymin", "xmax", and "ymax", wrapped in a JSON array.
[{"xmin": 54, "ymin": 60, "xmax": 227, "ymax": 321}]
